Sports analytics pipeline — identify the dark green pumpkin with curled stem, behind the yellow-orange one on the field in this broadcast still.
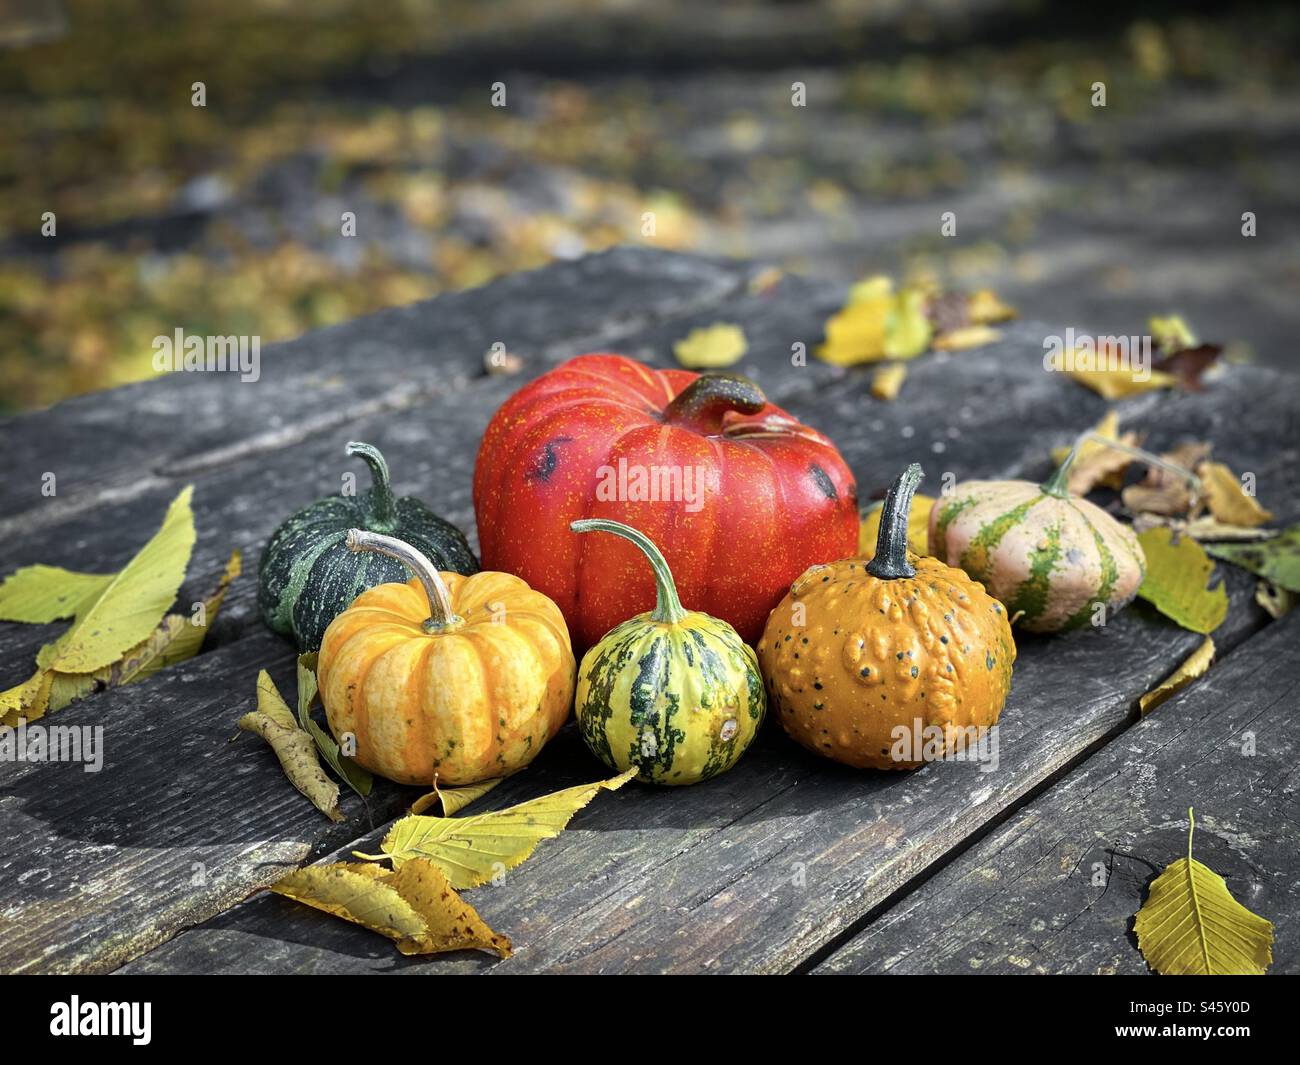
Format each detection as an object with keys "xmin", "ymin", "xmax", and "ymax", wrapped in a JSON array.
[{"xmin": 257, "ymin": 443, "xmax": 478, "ymax": 651}]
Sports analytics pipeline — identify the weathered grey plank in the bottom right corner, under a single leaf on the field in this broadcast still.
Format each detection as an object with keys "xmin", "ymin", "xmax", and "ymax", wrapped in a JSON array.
[{"xmin": 816, "ymin": 612, "xmax": 1300, "ymax": 973}]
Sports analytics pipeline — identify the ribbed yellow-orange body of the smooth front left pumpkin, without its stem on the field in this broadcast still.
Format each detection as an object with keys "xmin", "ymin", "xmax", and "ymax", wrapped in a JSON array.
[{"xmin": 319, "ymin": 572, "xmax": 575, "ymax": 784}]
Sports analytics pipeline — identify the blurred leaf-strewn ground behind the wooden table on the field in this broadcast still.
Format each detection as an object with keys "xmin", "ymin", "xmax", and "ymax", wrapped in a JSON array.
[{"xmin": 0, "ymin": 0, "xmax": 1300, "ymax": 411}]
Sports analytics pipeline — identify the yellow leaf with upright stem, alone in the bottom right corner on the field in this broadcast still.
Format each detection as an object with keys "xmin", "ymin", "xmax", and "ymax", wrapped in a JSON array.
[{"xmin": 1134, "ymin": 810, "xmax": 1273, "ymax": 977}]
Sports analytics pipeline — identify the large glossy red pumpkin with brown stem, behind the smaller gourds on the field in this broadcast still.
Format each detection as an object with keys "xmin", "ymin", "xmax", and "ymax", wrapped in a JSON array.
[{"xmin": 475, "ymin": 354, "xmax": 858, "ymax": 650}]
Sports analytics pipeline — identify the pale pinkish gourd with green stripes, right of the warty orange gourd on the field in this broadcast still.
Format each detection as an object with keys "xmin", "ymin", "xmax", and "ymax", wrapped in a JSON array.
[{"xmin": 930, "ymin": 453, "xmax": 1147, "ymax": 632}]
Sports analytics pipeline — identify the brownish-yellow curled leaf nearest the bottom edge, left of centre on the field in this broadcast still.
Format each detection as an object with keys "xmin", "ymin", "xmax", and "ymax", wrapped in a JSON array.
[{"xmin": 270, "ymin": 858, "xmax": 511, "ymax": 958}]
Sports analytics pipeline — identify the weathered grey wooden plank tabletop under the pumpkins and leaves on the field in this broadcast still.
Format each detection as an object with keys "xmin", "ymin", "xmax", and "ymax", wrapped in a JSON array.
[{"xmin": 0, "ymin": 248, "xmax": 1300, "ymax": 973}]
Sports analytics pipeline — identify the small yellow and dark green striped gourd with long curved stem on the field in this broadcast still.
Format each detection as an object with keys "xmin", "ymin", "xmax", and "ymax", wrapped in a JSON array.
[{"xmin": 569, "ymin": 519, "xmax": 767, "ymax": 784}]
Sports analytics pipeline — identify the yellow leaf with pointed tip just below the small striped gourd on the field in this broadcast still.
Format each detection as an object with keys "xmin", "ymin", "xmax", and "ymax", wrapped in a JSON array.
[{"xmin": 356, "ymin": 769, "xmax": 636, "ymax": 891}]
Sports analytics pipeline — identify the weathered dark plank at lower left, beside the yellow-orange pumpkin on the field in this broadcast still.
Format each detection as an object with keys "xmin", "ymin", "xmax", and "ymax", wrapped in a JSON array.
[{"xmin": 0, "ymin": 633, "xmax": 421, "ymax": 973}]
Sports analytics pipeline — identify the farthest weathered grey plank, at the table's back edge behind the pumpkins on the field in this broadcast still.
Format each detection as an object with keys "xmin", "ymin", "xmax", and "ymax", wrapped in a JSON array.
[{"xmin": 0, "ymin": 247, "xmax": 753, "ymax": 533}]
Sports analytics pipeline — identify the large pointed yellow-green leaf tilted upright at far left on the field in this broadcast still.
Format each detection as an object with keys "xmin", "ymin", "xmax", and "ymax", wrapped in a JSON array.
[{"xmin": 36, "ymin": 485, "xmax": 194, "ymax": 674}]
